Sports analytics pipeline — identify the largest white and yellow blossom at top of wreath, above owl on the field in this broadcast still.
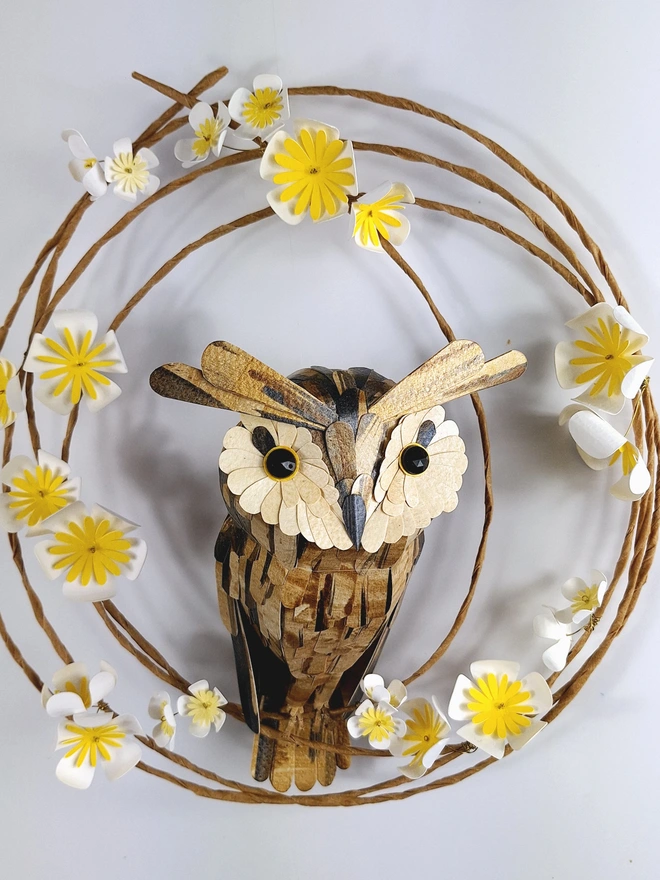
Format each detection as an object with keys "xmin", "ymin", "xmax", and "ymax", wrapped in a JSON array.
[{"xmin": 259, "ymin": 119, "xmax": 357, "ymax": 225}]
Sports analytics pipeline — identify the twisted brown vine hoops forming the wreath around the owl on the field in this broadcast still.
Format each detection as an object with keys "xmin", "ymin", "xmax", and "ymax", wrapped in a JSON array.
[{"xmin": 0, "ymin": 67, "xmax": 660, "ymax": 806}]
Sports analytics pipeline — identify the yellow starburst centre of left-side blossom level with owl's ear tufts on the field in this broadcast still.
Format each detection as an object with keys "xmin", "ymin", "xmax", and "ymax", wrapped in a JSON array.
[{"xmin": 37, "ymin": 327, "xmax": 115, "ymax": 403}]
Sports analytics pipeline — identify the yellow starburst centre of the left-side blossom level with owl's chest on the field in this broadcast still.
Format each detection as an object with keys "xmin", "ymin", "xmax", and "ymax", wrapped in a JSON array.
[{"xmin": 48, "ymin": 516, "xmax": 131, "ymax": 587}]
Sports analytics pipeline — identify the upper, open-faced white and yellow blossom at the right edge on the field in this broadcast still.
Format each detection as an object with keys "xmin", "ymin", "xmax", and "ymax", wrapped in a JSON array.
[{"xmin": 555, "ymin": 303, "xmax": 653, "ymax": 413}]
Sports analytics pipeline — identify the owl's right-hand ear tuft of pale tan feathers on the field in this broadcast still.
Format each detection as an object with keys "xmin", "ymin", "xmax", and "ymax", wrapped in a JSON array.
[{"xmin": 369, "ymin": 339, "xmax": 527, "ymax": 422}]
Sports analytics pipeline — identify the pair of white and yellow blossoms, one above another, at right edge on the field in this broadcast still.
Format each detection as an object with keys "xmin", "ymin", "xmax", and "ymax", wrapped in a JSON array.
[{"xmin": 555, "ymin": 303, "xmax": 653, "ymax": 501}]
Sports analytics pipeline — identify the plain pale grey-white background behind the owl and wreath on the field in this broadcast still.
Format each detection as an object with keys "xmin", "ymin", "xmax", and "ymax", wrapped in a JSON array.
[{"xmin": 0, "ymin": 0, "xmax": 660, "ymax": 880}]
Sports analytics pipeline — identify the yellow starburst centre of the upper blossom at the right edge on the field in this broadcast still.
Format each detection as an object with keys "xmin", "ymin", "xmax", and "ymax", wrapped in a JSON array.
[{"xmin": 570, "ymin": 317, "xmax": 638, "ymax": 397}]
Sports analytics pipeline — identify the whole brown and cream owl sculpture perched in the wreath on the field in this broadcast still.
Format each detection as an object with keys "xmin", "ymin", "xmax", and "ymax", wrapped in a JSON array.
[{"xmin": 151, "ymin": 340, "xmax": 526, "ymax": 791}]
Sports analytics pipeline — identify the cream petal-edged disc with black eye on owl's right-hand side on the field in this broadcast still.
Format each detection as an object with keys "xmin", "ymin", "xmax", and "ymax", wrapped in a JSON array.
[{"xmin": 362, "ymin": 406, "xmax": 467, "ymax": 553}]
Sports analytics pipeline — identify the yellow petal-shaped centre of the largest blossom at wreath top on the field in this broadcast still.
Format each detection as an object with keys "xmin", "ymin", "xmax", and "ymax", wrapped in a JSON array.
[{"xmin": 273, "ymin": 128, "xmax": 355, "ymax": 220}]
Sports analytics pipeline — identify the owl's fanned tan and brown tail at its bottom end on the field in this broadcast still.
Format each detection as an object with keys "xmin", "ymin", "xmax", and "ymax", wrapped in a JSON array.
[{"xmin": 252, "ymin": 706, "xmax": 351, "ymax": 791}]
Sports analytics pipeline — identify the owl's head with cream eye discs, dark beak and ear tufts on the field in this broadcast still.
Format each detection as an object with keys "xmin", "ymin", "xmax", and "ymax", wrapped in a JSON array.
[{"xmin": 151, "ymin": 340, "xmax": 526, "ymax": 553}]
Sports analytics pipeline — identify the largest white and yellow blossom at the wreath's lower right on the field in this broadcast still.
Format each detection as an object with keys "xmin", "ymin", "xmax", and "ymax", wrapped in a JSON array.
[{"xmin": 448, "ymin": 660, "xmax": 552, "ymax": 758}]
